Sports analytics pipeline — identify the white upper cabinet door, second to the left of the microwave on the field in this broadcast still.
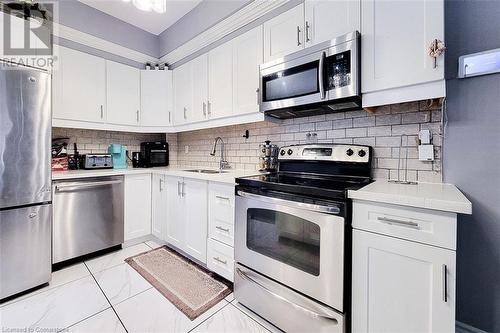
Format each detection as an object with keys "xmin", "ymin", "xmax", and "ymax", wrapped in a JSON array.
[{"xmin": 207, "ymin": 42, "xmax": 233, "ymax": 118}]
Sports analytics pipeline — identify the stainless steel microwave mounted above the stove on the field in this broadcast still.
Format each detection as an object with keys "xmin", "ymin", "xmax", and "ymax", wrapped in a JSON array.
[{"xmin": 259, "ymin": 31, "xmax": 361, "ymax": 119}]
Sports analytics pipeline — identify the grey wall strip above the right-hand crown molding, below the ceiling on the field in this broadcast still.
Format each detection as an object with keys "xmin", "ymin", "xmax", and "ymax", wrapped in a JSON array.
[{"xmin": 159, "ymin": 0, "xmax": 252, "ymax": 56}]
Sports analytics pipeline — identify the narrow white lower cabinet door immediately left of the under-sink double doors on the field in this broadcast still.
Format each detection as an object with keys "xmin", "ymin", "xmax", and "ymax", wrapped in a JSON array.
[{"xmin": 151, "ymin": 174, "xmax": 169, "ymax": 241}]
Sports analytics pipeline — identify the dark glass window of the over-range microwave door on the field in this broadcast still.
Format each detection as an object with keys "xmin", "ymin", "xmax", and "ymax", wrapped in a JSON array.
[{"xmin": 262, "ymin": 61, "xmax": 319, "ymax": 102}]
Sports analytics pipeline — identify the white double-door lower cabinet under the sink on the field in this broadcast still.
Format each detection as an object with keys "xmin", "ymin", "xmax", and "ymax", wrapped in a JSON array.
[{"xmin": 165, "ymin": 176, "xmax": 208, "ymax": 263}]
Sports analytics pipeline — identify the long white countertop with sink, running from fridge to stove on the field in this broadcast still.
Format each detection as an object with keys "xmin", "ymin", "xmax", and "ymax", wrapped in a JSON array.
[{"xmin": 52, "ymin": 167, "xmax": 259, "ymax": 184}]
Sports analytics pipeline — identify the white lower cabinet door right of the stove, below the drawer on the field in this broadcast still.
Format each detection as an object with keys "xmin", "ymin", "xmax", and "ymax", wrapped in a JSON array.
[{"xmin": 352, "ymin": 230, "xmax": 455, "ymax": 332}]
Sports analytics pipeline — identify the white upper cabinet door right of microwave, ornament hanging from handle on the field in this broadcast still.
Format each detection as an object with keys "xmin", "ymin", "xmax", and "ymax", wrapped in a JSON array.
[{"xmin": 361, "ymin": 0, "xmax": 444, "ymax": 92}]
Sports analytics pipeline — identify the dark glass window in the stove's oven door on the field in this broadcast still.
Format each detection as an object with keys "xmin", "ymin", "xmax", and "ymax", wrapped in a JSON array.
[{"xmin": 247, "ymin": 208, "xmax": 320, "ymax": 276}]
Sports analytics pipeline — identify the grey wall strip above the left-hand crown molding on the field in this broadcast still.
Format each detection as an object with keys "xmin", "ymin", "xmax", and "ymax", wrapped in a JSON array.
[{"xmin": 56, "ymin": 0, "xmax": 160, "ymax": 58}]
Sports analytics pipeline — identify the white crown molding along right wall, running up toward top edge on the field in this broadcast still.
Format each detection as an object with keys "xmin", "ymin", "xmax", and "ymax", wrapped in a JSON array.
[{"xmin": 160, "ymin": 0, "xmax": 289, "ymax": 65}]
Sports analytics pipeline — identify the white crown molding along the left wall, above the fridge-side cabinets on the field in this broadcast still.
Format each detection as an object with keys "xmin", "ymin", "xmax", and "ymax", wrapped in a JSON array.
[{"xmin": 54, "ymin": 23, "xmax": 158, "ymax": 64}]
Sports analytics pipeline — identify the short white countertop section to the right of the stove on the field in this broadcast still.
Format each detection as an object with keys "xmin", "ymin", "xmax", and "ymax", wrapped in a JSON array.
[{"xmin": 348, "ymin": 180, "xmax": 472, "ymax": 214}]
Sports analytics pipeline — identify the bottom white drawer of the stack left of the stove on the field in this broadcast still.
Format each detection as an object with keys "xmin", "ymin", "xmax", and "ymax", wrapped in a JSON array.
[{"xmin": 207, "ymin": 239, "xmax": 234, "ymax": 282}]
